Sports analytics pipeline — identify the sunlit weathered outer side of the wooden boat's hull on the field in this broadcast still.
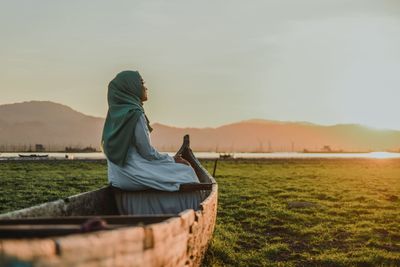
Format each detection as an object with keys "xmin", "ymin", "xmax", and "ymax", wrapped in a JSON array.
[{"xmin": 0, "ymin": 185, "xmax": 217, "ymax": 266}]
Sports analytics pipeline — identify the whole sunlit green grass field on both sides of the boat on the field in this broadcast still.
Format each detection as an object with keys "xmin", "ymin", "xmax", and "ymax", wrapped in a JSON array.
[{"xmin": 0, "ymin": 159, "xmax": 400, "ymax": 266}]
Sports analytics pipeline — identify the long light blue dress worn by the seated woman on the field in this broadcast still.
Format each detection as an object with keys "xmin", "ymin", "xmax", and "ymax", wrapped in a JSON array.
[{"xmin": 107, "ymin": 115, "xmax": 199, "ymax": 191}]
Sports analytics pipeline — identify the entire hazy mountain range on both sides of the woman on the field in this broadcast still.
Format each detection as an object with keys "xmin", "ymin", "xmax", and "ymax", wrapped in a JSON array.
[{"xmin": 0, "ymin": 101, "xmax": 400, "ymax": 152}]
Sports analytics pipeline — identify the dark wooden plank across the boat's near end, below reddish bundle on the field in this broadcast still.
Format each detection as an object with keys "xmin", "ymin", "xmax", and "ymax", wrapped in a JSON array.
[{"xmin": 0, "ymin": 214, "xmax": 178, "ymax": 225}]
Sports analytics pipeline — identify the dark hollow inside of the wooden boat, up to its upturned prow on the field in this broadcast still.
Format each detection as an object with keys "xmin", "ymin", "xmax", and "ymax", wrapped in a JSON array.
[{"xmin": 0, "ymin": 135, "xmax": 216, "ymax": 238}]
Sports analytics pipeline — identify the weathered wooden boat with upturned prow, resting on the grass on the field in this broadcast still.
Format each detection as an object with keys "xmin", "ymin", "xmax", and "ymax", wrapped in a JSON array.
[{"xmin": 0, "ymin": 136, "xmax": 218, "ymax": 266}]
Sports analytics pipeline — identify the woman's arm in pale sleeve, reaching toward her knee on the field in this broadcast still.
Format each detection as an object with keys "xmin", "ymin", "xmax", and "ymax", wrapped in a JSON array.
[{"xmin": 135, "ymin": 115, "xmax": 175, "ymax": 162}]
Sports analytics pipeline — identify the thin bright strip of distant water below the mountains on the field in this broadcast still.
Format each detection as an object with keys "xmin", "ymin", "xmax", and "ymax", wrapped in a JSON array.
[{"xmin": 0, "ymin": 152, "xmax": 400, "ymax": 160}]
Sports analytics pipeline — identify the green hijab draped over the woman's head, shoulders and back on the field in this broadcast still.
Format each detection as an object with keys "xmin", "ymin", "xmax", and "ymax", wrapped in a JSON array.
[{"xmin": 102, "ymin": 70, "xmax": 151, "ymax": 166}]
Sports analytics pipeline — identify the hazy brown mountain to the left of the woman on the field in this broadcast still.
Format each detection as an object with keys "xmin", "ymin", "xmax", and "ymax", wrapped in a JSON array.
[{"xmin": 0, "ymin": 101, "xmax": 104, "ymax": 150}]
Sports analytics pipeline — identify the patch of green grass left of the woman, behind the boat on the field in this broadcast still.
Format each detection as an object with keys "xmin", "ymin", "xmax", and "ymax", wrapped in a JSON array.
[{"xmin": 0, "ymin": 161, "xmax": 107, "ymax": 213}]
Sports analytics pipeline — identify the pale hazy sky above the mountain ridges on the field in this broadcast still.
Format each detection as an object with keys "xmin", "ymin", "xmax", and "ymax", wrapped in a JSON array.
[{"xmin": 0, "ymin": 0, "xmax": 400, "ymax": 130}]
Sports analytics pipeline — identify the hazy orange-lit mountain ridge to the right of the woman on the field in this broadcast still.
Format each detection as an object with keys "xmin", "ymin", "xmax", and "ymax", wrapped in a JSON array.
[{"xmin": 152, "ymin": 120, "xmax": 400, "ymax": 152}]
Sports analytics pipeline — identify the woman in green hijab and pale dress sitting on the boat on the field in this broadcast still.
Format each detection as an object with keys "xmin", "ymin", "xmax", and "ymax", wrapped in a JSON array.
[{"xmin": 102, "ymin": 71, "xmax": 199, "ymax": 191}]
